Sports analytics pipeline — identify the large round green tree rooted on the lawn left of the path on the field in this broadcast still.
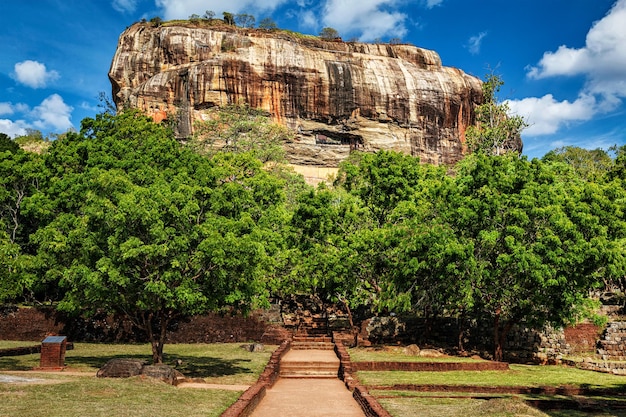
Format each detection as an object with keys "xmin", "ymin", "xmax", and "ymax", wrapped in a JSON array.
[{"xmin": 35, "ymin": 111, "xmax": 284, "ymax": 363}]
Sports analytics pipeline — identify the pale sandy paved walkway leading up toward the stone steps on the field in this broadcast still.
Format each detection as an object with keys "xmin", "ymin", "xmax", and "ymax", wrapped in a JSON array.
[{"xmin": 252, "ymin": 350, "xmax": 365, "ymax": 417}]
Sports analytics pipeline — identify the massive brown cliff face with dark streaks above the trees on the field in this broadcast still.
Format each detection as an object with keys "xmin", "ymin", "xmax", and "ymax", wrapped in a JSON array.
[{"xmin": 109, "ymin": 23, "xmax": 482, "ymax": 167}]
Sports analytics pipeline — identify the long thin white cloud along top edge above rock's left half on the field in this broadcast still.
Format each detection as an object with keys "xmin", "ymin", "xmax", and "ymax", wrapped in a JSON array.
[{"xmin": 155, "ymin": 0, "xmax": 287, "ymax": 20}]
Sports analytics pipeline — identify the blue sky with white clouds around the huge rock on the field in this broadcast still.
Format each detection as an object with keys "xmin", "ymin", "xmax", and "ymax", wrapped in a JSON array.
[{"xmin": 0, "ymin": 0, "xmax": 626, "ymax": 157}]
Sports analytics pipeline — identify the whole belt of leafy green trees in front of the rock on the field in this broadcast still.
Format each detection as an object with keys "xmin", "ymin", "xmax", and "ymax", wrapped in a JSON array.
[{"xmin": 0, "ymin": 101, "xmax": 626, "ymax": 362}]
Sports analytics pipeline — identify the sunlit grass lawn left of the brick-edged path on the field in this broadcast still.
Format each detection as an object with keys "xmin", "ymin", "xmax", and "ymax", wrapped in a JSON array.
[{"xmin": 0, "ymin": 342, "xmax": 276, "ymax": 417}]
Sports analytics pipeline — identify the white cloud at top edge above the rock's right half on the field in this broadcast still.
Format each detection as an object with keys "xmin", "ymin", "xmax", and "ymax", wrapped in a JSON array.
[{"xmin": 322, "ymin": 0, "xmax": 408, "ymax": 41}]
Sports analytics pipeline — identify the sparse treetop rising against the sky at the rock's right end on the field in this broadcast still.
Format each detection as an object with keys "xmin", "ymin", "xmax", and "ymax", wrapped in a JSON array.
[{"xmin": 465, "ymin": 74, "xmax": 527, "ymax": 155}]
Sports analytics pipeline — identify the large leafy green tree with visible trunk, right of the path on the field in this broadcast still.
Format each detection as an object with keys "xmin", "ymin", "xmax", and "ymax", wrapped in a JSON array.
[{"xmin": 445, "ymin": 154, "xmax": 624, "ymax": 360}]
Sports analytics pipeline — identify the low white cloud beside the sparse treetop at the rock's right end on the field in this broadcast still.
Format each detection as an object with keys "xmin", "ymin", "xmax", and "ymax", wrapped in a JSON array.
[{"xmin": 506, "ymin": 94, "xmax": 598, "ymax": 136}]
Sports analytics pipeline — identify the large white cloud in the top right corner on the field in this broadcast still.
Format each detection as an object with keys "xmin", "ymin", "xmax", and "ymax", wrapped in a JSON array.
[{"xmin": 528, "ymin": 0, "xmax": 626, "ymax": 101}]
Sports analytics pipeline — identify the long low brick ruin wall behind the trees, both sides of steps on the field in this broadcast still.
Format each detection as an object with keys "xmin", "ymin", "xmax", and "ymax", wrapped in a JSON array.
[{"xmin": 0, "ymin": 308, "xmax": 626, "ymax": 363}]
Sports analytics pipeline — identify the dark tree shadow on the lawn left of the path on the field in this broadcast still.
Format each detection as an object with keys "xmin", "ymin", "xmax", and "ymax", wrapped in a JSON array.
[{"xmin": 64, "ymin": 354, "xmax": 254, "ymax": 378}]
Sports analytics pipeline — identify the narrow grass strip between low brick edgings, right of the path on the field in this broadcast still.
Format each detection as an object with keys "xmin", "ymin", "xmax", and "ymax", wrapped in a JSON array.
[{"xmin": 357, "ymin": 365, "xmax": 626, "ymax": 391}]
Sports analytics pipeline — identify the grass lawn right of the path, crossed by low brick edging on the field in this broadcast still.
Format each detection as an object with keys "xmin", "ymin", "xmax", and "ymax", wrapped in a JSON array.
[{"xmin": 357, "ymin": 365, "xmax": 626, "ymax": 417}]
